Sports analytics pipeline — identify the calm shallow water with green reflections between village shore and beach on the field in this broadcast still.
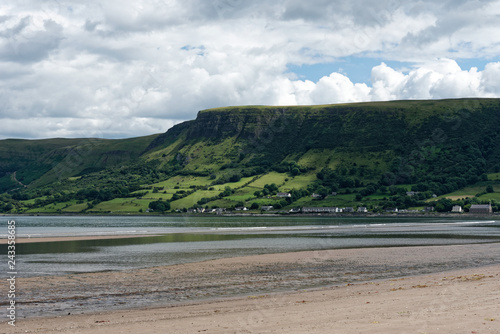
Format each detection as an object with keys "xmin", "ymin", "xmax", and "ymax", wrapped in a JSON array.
[{"xmin": 0, "ymin": 217, "xmax": 500, "ymax": 277}]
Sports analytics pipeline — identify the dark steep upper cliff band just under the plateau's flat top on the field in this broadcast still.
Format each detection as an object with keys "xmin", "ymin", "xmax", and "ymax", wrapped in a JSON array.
[{"xmin": 153, "ymin": 99, "xmax": 500, "ymax": 162}]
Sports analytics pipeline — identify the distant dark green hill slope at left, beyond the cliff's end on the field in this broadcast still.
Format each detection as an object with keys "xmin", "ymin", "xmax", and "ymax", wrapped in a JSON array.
[{"xmin": 0, "ymin": 135, "xmax": 157, "ymax": 187}]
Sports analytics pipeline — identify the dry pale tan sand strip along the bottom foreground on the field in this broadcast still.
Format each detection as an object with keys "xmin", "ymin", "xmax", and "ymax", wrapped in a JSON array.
[{"xmin": 9, "ymin": 258, "xmax": 500, "ymax": 333}]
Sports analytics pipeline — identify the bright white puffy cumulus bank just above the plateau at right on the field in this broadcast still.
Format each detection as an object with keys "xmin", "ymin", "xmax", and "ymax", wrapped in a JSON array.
[{"xmin": 290, "ymin": 58, "xmax": 500, "ymax": 104}]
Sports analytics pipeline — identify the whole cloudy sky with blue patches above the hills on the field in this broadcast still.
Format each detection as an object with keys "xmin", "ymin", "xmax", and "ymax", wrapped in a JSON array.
[{"xmin": 0, "ymin": 0, "xmax": 500, "ymax": 139}]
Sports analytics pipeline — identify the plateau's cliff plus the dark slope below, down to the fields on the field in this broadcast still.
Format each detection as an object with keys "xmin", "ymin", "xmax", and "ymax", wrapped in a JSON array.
[{"xmin": 137, "ymin": 99, "xmax": 500, "ymax": 193}]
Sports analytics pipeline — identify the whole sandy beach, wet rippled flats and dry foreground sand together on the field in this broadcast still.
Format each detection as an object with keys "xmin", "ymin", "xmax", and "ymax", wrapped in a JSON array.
[{"xmin": 6, "ymin": 244, "xmax": 500, "ymax": 333}]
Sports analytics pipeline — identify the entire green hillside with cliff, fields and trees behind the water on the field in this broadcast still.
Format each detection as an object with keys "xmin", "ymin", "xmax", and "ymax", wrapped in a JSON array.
[{"xmin": 0, "ymin": 99, "xmax": 500, "ymax": 212}]
